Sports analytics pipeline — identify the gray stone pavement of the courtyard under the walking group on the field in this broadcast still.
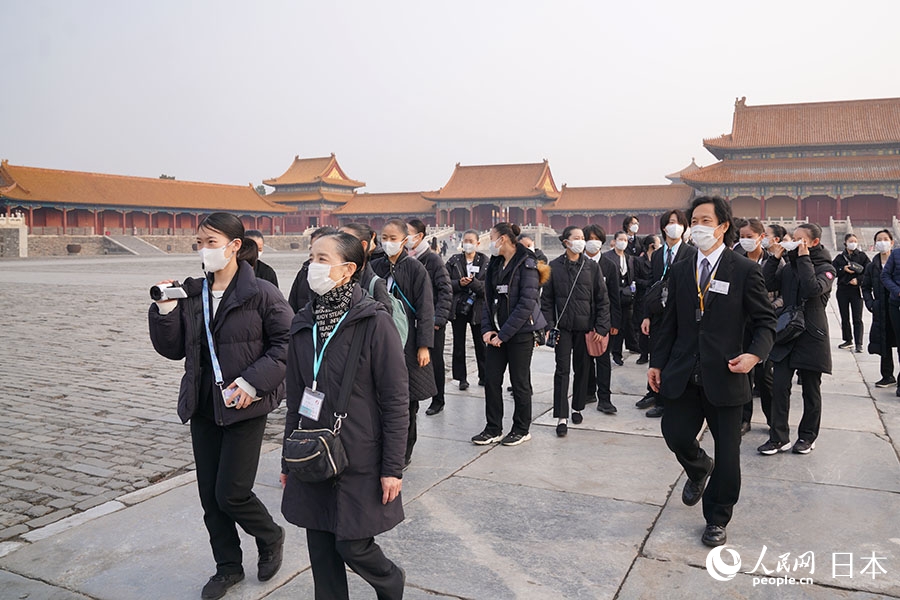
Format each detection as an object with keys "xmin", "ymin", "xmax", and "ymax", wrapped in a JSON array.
[{"xmin": 0, "ymin": 253, "xmax": 900, "ymax": 600}]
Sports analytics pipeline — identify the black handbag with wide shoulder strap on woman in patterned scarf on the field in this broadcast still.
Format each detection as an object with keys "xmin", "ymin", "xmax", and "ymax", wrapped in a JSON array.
[{"xmin": 281, "ymin": 322, "xmax": 366, "ymax": 483}]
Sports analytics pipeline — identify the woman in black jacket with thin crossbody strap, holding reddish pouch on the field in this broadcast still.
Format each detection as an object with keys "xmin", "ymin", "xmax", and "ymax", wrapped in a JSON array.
[{"xmin": 541, "ymin": 226, "xmax": 609, "ymax": 437}]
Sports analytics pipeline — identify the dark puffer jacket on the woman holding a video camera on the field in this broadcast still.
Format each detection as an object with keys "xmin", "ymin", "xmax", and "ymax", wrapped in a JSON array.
[{"xmin": 149, "ymin": 261, "xmax": 293, "ymax": 426}]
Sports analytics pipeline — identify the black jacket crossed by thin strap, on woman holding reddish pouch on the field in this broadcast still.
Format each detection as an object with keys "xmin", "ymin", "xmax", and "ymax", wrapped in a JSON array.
[{"xmin": 541, "ymin": 254, "xmax": 610, "ymax": 335}]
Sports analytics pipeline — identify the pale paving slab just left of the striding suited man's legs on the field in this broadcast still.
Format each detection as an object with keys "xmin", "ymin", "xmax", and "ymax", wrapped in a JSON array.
[{"xmin": 457, "ymin": 427, "xmax": 681, "ymax": 506}]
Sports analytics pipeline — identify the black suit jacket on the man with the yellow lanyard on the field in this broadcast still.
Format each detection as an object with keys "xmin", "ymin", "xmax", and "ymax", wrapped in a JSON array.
[{"xmin": 650, "ymin": 249, "xmax": 775, "ymax": 406}]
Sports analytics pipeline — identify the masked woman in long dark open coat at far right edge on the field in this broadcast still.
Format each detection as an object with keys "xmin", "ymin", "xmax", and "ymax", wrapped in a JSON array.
[{"xmin": 862, "ymin": 229, "xmax": 900, "ymax": 387}]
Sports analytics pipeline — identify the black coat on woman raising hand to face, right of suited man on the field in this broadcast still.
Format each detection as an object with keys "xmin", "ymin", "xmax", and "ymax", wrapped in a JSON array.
[{"xmin": 763, "ymin": 244, "xmax": 837, "ymax": 373}]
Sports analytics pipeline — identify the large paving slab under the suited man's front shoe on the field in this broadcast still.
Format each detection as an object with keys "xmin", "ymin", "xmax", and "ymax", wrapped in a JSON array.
[{"xmin": 644, "ymin": 475, "xmax": 900, "ymax": 596}]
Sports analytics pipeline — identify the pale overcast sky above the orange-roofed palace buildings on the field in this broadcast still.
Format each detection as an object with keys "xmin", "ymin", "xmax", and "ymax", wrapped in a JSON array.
[{"xmin": 0, "ymin": 0, "xmax": 900, "ymax": 192}]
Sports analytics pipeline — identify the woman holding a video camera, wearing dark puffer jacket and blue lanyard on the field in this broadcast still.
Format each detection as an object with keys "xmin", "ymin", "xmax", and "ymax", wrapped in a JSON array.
[{"xmin": 149, "ymin": 213, "xmax": 292, "ymax": 598}]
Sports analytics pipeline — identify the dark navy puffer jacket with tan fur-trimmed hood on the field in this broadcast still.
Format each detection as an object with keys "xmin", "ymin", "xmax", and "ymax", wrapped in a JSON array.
[{"xmin": 481, "ymin": 244, "xmax": 550, "ymax": 342}]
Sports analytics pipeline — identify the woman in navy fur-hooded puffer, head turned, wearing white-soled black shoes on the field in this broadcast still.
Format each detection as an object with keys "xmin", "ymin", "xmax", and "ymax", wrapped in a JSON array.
[{"xmin": 472, "ymin": 223, "xmax": 550, "ymax": 446}]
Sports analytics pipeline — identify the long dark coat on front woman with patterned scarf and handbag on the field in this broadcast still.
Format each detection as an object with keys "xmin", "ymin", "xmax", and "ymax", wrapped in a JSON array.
[{"xmin": 281, "ymin": 285, "xmax": 409, "ymax": 540}]
